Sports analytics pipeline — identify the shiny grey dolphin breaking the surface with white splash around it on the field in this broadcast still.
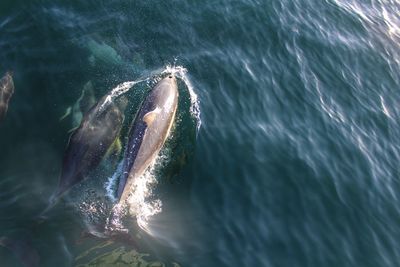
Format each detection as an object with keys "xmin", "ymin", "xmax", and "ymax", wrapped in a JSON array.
[{"xmin": 117, "ymin": 75, "xmax": 178, "ymax": 203}]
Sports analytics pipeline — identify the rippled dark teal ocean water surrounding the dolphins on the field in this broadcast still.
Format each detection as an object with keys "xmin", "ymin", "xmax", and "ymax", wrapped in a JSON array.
[{"xmin": 0, "ymin": 0, "xmax": 400, "ymax": 267}]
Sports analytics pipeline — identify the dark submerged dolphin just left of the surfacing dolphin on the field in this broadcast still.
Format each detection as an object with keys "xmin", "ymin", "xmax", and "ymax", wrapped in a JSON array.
[{"xmin": 55, "ymin": 96, "xmax": 127, "ymax": 196}]
